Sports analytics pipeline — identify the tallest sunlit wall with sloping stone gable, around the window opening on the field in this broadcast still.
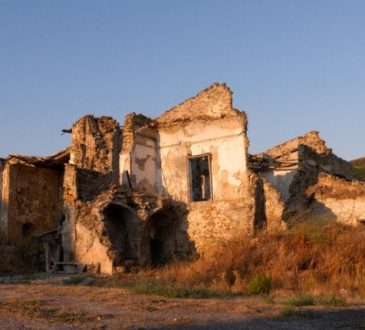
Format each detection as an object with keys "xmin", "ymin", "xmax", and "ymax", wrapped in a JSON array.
[{"xmin": 155, "ymin": 84, "xmax": 256, "ymax": 253}]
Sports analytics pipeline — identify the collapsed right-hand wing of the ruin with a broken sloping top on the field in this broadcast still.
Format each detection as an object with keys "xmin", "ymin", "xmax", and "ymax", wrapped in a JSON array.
[{"xmin": 249, "ymin": 131, "xmax": 365, "ymax": 226}]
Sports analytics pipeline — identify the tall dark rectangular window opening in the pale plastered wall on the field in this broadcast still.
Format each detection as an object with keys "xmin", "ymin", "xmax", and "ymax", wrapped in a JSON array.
[{"xmin": 189, "ymin": 155, "xmax": 212, "ymax": 202}]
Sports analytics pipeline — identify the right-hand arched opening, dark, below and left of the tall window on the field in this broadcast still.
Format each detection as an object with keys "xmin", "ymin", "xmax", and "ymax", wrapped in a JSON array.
[{"xmin": 147, "ymin": 210, "xmax": 179, "ymax": 267}]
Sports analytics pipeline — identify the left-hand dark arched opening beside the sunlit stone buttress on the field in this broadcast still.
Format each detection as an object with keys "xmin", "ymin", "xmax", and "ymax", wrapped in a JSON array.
[{"xmin": 104, "ymin": 204, "xmax": 138, "ymax": 267}]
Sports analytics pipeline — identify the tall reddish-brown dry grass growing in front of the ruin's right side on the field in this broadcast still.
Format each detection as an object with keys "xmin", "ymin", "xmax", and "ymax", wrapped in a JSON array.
[{"xmin": 130, "ymin": 222, "xmax": 365, "ymax": 296}]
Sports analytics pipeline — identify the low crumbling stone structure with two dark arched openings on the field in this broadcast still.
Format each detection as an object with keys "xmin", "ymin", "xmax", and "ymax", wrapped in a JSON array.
[{"xmin": 69, "ymin": 188, "xmax": 193, "ymax": 274}]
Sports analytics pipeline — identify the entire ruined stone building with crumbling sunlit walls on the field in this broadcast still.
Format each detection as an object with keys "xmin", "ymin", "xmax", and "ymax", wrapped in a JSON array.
[{"xmin": 0, "ymin": 83, "xmax": 365, "ymax": 273}]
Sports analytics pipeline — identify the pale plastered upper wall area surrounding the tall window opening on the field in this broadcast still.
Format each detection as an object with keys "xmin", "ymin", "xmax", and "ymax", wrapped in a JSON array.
[{"xmin": 159, "ymin": 116, "xmax": 247, "ymax": 203}]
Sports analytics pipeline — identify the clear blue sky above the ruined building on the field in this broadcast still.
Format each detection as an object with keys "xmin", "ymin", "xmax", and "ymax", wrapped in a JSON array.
[{"xmin": 0, "ymin": 0, "xmax": 365, "ymax": 159}]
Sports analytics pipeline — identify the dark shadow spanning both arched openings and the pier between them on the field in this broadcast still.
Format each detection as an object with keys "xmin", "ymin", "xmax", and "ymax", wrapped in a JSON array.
[{"xmin": 103, "ymin": 203, "xmax": 195, "ymax": 267}]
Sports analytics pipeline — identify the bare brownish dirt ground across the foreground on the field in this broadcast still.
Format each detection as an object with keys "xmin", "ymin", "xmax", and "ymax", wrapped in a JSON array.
[{"xmin": 0, "ymin": 282, "xmax": 365, "ymax": 329}]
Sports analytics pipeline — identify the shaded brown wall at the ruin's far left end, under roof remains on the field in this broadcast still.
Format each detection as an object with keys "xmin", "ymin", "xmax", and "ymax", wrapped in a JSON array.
[{"xmin": 2, "ymin": 164, "xmax": 63, "ymax": 245}]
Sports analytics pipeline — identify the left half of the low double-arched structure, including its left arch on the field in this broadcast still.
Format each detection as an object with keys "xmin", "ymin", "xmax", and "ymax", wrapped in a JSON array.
[{"xmin": 75, "ymin": 190, "xmax": 141, "ymax": 273}]
